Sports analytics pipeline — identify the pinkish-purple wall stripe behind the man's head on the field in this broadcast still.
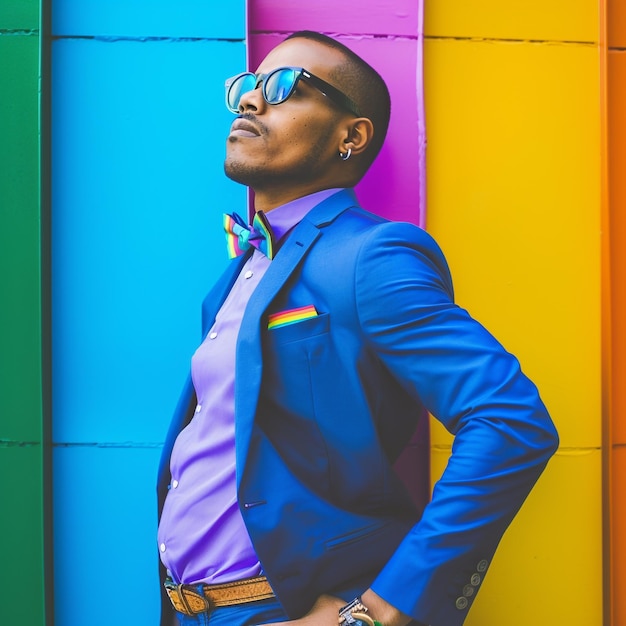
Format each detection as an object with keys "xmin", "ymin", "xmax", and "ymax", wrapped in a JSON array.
[{"xmin": 248, "ymin": 0, "xmax": 425, "ymax": 225}]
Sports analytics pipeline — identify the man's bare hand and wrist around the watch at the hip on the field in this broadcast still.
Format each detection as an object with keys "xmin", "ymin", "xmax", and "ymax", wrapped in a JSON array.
[{"xmin": 258, "ymin": 589, "xmax": 411, "ymax": 626}]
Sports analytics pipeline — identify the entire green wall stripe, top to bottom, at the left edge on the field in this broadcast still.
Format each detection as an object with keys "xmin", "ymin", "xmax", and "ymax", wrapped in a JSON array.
[{"xmin": 0, "ymin": 0, "xmax": 49, "ymax": 626}]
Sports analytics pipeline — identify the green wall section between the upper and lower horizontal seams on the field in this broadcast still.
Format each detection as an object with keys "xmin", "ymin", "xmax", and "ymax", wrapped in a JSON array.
[{"xmin": 0, "ymin": 35, "xmax": 41, "ymax": 438}]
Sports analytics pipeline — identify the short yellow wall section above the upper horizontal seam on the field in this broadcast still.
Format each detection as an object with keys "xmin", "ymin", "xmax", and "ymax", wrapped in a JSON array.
[{"xmin": 424, "ymin": 0, "xmax": 598, "ymax": 41}]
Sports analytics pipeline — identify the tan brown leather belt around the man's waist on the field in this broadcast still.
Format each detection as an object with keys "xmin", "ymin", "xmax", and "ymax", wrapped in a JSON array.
[{"xmin": 165, "ymin": 576, "xmax": 274, "ymax": 615}]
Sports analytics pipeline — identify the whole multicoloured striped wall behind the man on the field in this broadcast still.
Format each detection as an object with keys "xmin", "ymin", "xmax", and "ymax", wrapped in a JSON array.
[{"xmin": 0, "ymin": 0, "xmax": 626, "ymax": 626}]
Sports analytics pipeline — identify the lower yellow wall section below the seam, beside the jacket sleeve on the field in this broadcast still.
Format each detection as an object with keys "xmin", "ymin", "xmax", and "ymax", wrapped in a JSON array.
[{"xmin": 432, "ymin": 448, "xmax": 602, "ymax": 626}]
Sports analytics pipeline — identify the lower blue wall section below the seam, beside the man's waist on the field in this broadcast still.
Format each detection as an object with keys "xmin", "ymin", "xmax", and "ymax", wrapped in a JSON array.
[{"xmin": 53, "ymin": 446, "xmax": 160, "ymax": 626}]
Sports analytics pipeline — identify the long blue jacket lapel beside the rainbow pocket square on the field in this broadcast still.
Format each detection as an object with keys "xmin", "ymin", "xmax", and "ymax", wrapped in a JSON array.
[{"xmin": 235, "ymin": 190, "xmax": 358, "ymax": 488}]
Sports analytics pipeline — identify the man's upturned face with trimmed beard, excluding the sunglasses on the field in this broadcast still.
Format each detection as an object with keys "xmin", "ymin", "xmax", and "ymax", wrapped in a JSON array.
[{"xmin": 224, "ymin": 38, "xmax": 353, "ymax": 191}]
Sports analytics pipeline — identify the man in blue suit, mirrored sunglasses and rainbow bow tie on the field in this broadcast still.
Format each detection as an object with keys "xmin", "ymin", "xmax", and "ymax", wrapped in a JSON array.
[{"xmin": 159, "ymin": 32, "xmax": 557, "ymax": 626}]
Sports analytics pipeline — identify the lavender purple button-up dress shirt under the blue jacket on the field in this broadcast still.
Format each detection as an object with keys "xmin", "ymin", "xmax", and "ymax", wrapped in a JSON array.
[{"xmin": 158, "ymin": 189, "xmax": 339, "ymax": 584}]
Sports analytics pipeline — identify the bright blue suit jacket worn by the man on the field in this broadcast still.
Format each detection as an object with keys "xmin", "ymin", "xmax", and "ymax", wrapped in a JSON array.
[{"xmin": 162, "ymin": 191, "xmax": 558, "ymax": 626}]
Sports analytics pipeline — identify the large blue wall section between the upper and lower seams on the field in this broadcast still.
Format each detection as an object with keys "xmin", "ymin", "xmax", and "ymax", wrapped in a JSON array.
[{"xmin": 52, "ymin": 39, "xmax": 245, "ymax": 442}]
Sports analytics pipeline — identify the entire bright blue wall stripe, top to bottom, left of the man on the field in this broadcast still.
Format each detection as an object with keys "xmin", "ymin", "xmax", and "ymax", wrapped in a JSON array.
[{"xmin": 52, "ymin": 0, "xmax": 246, "ymax": 626}]
